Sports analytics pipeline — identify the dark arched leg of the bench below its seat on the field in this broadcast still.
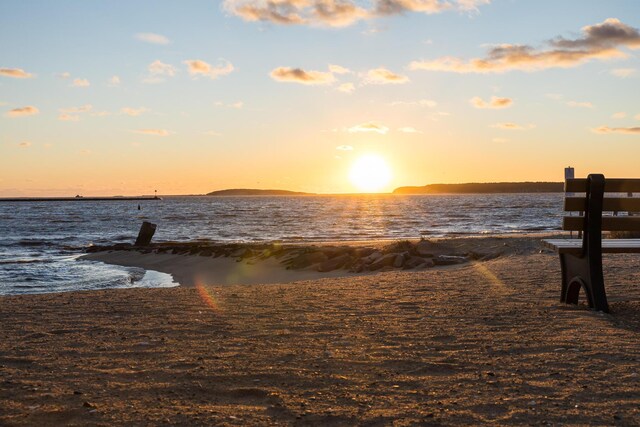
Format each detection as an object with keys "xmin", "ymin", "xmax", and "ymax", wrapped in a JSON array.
[{"xmin": 560, "ymin": 254, "xmax": 609, "ymax": 313}]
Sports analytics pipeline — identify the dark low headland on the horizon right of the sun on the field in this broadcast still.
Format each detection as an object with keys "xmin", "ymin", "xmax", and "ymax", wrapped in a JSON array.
[{"xmin": 393, "ymin": 182, "xmax": 564, "ymax": 194}]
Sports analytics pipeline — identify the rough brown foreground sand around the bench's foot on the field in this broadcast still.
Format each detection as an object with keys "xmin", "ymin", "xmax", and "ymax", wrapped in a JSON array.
[{"xmin": 0, "ymin": 241, "xmax": 640, "ymax": 425}]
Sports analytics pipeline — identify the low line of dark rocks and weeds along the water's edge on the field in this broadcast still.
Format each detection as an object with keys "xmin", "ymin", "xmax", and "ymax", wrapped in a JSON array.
[{"xmin": 87, "ymin": 240, "xmax": 495, "ymax": 273}]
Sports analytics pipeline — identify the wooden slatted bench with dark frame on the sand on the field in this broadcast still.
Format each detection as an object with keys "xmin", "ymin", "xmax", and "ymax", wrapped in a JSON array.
[{"xmin": 543, "ymin": 174, "xmax": 640, "ymax": 313}]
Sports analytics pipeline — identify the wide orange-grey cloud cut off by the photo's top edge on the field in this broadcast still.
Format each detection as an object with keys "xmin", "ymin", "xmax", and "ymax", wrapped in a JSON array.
[{"xmin": 223, "ymin": 0, "xmax": 490, "ymax": 27}]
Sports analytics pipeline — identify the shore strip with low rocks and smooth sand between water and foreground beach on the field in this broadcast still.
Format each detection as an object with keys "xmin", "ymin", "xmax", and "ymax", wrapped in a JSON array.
[{"xmin": 79, "ymin": 234, "xmax": 560, "ymax": 286}]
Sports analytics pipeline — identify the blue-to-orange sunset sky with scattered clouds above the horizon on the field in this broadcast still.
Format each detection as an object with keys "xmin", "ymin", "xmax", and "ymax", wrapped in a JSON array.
[{"xmin": 0, "ymin": 0, "xmax": 640, "ymax": 197}]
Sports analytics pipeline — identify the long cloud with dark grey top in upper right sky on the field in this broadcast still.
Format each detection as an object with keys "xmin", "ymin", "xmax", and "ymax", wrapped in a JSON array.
[{"xmin": 409, "ymin": 18, "xmax": 640, "ymax": 73}]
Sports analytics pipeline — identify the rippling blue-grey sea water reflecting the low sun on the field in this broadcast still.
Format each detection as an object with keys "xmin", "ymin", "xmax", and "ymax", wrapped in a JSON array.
[{"xmin": 0, "ymin": 193, "xmax": 563, "ymax": 295}]
